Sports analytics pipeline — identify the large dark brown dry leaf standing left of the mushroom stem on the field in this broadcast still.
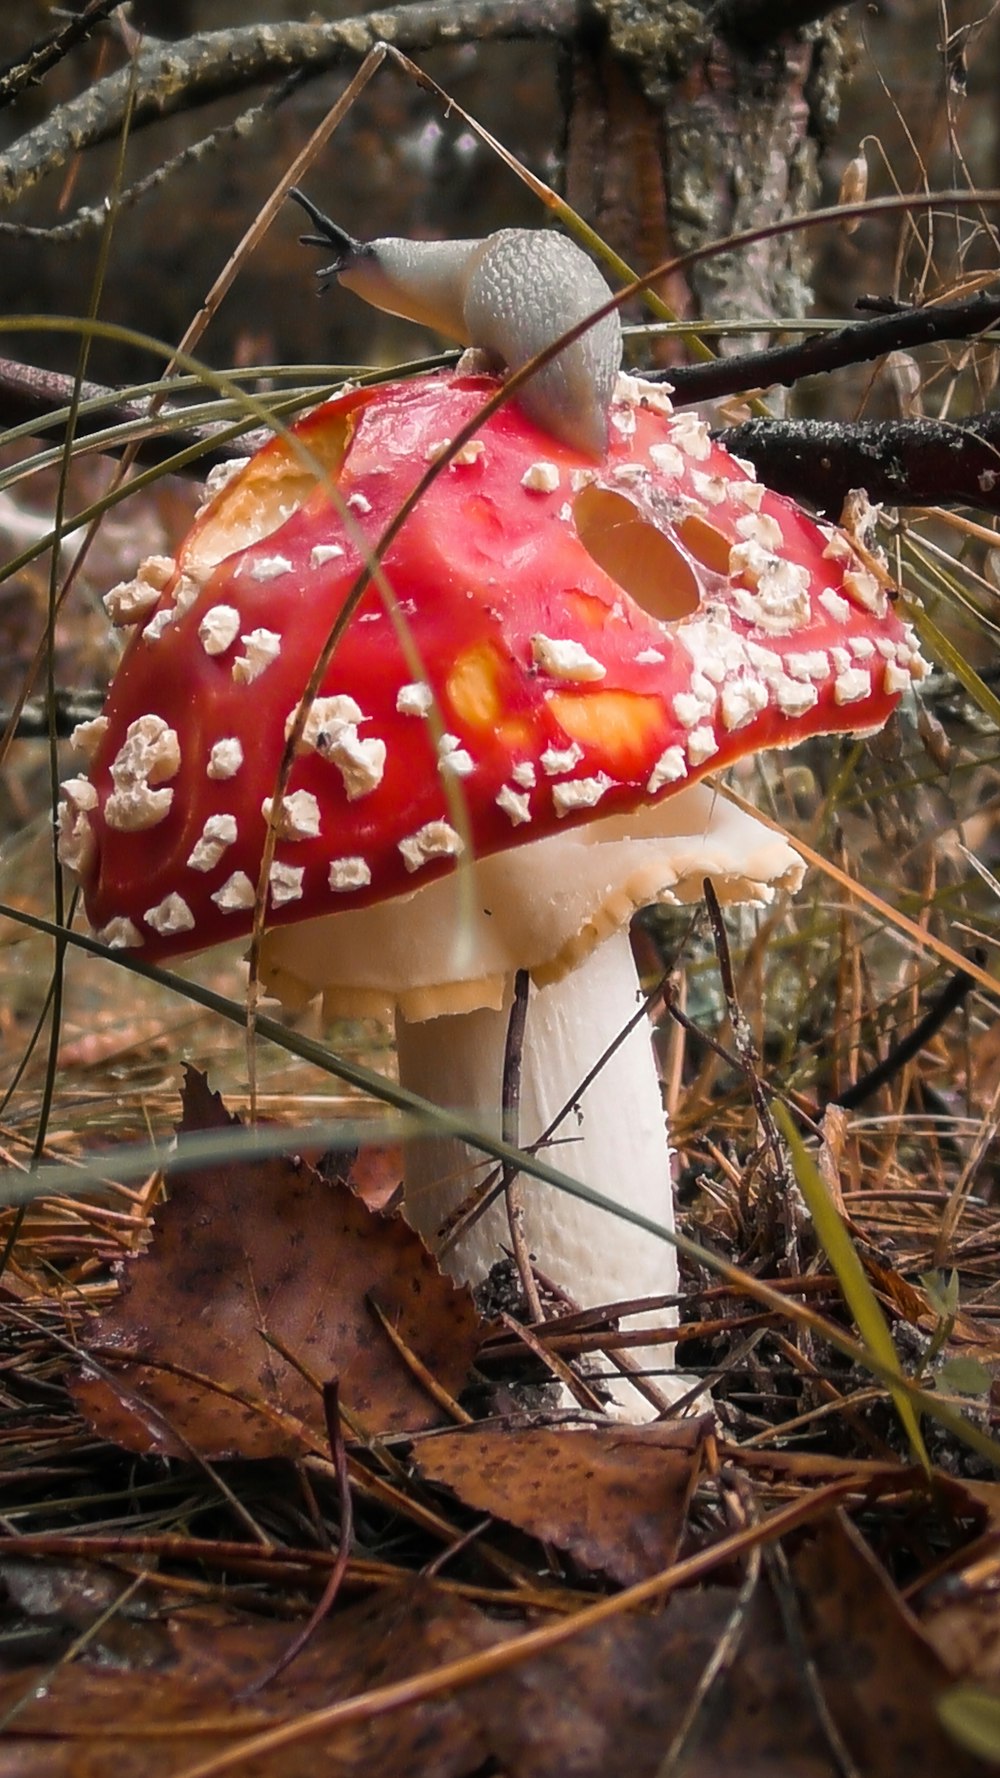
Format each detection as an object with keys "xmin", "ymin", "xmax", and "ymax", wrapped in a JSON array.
[{"xmin": 75, "ymin": 1070, "xmax": 480, "ymax": 1458}]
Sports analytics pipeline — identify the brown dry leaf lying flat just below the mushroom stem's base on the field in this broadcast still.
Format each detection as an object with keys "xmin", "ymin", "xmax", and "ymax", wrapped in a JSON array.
[{"xmin": 415, "ymin": 1415, "xmax": 714, "ymax": 1586}]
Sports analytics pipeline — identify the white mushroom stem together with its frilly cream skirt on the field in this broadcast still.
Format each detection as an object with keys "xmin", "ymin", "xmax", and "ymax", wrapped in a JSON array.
[{"xmin": 262, "ymin": 784, "xmax": 802, "ymax": 1415}]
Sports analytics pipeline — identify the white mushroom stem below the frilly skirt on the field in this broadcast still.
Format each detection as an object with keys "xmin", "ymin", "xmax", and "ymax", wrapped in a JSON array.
[{"xmin": 397, "ymin": 930, "xmax": 678, "ymax": 1401}]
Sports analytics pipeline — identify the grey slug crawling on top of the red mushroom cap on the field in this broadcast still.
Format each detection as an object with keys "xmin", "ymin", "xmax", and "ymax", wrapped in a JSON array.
[{"xmin": 292, "ymin": 192, "xmax": 621, "ymax": 457}]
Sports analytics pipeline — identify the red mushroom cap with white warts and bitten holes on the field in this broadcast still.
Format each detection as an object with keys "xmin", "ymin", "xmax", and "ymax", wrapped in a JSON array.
[{"xmin": 60, "ymin": 373, "xmax": 923, "ymax": 958}]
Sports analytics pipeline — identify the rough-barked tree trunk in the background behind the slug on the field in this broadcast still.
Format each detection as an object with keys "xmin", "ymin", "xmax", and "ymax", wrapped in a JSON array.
[{"xmin": 566, "ymin": 0, "xmax": 845, "ymax": 337}]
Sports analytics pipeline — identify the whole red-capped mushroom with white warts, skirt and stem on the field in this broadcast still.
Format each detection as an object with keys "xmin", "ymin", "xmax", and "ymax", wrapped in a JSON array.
[{"xmin": 60, "ymin": 373, "xmax": 923, "ymax": 1415}]
